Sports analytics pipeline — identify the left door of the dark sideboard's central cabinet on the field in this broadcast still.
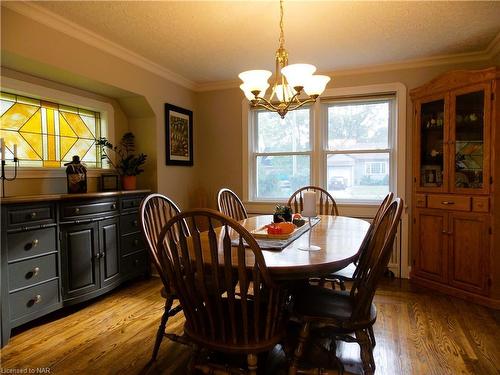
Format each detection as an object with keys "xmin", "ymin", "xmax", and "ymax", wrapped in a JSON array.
[{"xmin": 61, "ymin": 223, "xmax": 100, "ymax": 300}]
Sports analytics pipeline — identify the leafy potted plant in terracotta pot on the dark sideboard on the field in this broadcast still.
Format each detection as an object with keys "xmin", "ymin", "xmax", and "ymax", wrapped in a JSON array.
[{"xmin": 96, "ymin": 132, "xmax": 147, "ymax": 190}]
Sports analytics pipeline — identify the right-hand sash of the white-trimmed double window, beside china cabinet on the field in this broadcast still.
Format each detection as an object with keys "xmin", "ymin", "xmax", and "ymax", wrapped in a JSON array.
[{"xmin": 322, "ymin": 96, "xmax": 395, "ymax": 202}]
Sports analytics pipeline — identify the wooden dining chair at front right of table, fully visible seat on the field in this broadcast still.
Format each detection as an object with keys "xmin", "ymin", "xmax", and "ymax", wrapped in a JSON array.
[{"xmin": 289, "ymin": 198, "xmax": 403, "ymax": 375}]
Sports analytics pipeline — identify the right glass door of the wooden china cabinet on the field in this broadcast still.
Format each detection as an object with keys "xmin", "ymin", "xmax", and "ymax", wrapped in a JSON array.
[{"xmin": 450, "ymin": 84, "xmax": 491, "ymax": 193}]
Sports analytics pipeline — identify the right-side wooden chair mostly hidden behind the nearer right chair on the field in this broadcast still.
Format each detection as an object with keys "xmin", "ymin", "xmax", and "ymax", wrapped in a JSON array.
[{"xmin": 320, "ymin": 192, "xmax": 394, "ymax": 290}]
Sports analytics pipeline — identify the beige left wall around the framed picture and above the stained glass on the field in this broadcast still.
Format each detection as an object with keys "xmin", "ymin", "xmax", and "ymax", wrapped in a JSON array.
[{"xmin": 1, "ymin": 8, "xmax": 198, "ymax": 207}]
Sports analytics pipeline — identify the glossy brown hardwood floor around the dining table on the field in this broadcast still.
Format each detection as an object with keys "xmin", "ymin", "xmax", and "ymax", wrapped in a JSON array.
[{"xmin": 0, "ymin": 278, "xmax": 500, "ymax": 375}]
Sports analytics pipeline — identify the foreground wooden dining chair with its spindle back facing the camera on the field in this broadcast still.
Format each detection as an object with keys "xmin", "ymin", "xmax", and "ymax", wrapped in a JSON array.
[{"xmin": 159, "ymin": 209, "xmax": 287, "ymax": 375}]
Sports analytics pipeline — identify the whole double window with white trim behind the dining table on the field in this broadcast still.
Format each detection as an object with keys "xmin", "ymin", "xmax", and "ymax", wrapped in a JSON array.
[{"xmin": 244, "ymin": 89, "xmax": 398, "ymax": 205}]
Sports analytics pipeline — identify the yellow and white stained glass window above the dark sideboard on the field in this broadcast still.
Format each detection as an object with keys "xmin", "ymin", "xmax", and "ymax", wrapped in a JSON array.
[{"xmin": 0, "ymin": 92, "xmax": 101, "ymax": 168}]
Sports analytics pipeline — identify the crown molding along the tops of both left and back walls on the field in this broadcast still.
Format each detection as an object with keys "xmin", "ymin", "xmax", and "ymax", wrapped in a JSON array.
[{"xmin": 2, "ymin": 1, "xmax": 500, "ymax": 92}]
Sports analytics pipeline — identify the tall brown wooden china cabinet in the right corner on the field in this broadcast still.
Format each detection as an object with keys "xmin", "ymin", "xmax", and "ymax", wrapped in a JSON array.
[{"xmin": 410, "ymin": 68, "xmax": 500, "ymax": 308}]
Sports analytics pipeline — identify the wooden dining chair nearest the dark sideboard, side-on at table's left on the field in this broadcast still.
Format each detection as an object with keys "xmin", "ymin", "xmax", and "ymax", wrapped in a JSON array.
[{"xmin": 139, "ymin": 193, "xmax": 189, "ymax": 361}]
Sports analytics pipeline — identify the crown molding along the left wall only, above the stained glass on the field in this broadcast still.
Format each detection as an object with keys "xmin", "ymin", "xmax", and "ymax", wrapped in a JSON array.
[{"xmin": 2, "ymin": 1, "xmax": 196, "ymax": 90}]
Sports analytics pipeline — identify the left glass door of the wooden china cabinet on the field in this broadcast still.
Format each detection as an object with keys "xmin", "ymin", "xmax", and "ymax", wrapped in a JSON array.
[{"xmin": 417, "ymin": 97, "xmax": 447, "ymax": 191}]
